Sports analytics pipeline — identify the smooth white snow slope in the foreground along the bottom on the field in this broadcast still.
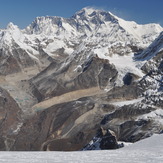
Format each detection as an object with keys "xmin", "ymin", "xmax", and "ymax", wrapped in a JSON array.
[{"xmin": 0, "ymin": 134, "xmax": 163, "ymax": 163}]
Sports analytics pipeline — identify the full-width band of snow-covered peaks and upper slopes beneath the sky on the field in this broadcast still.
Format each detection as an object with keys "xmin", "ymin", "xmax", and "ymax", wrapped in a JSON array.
[{"xmin": 0, "ymin": 7, "xmax": 163, "ymax": 74}]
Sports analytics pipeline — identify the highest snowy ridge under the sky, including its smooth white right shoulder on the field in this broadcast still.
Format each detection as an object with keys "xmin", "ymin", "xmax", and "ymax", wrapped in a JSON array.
[{"xmin": 26, "ymin": 7, "xmax": 163, "ymax": 44}]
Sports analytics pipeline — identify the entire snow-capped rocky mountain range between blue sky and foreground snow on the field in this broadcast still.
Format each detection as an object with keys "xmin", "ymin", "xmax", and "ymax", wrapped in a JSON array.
[{"xmin": 0, "ymin": 8, "xmax": 163, "ymax": 151}]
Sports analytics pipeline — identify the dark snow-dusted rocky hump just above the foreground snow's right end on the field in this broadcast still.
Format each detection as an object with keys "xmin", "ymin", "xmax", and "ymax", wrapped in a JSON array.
[{"xmin": 101, "ymin": 104, "xmax": 162, "ymax": 142}]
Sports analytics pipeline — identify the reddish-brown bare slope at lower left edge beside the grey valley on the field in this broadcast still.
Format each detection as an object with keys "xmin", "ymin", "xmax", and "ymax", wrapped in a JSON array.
[{"xmin": 0, "ymin": 88, "xmax": 22, "ymax": 151}]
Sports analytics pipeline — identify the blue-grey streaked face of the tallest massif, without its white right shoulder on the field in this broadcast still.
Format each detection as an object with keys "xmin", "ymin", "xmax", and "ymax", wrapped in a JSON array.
[{"xmin": 26, "ymin": 8, "xmax": 117, "ymax": 37}]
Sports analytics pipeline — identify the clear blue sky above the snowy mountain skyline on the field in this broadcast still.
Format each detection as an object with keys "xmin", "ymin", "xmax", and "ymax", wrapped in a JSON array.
[{"xmin": 0, "ymin": 0, "xmax": 163, "ymax": 28}]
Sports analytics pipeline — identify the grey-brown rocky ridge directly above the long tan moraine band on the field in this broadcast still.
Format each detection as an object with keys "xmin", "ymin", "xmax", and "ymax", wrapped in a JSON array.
[{"xmin": 31, "ymin": 57, "xmax": 117, "ymax": 98}]
